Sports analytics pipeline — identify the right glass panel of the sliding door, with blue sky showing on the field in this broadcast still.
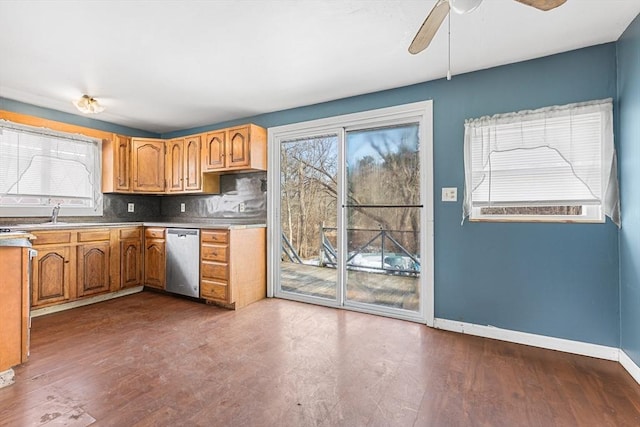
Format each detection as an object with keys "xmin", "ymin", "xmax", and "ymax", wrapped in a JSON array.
[{"xmin": 342, "ymin": 123, "xmax": 422, "ymax": 312}]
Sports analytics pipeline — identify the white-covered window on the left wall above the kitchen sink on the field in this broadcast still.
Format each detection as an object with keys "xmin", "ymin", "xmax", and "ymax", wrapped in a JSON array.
[{"xmin": 0, "ymin": 121, "xmax": 102, "ymax": 216}]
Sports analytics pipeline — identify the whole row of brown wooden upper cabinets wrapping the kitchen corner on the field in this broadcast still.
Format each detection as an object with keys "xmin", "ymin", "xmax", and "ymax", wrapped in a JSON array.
[{"xmin": 102, "ymin": 124, "xmax": 267, "ymax": 194}]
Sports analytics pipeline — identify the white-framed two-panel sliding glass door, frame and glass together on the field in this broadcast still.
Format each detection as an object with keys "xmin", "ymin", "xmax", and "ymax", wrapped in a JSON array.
[{"xmin": 269, "ymin": 104, "xmax": 433, "ymax": 322}]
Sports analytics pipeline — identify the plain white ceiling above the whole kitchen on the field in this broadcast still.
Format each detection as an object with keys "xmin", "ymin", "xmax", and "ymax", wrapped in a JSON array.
[{"xmin": 0, "ymin": 0, "xmax": 640, "ymax": 133}]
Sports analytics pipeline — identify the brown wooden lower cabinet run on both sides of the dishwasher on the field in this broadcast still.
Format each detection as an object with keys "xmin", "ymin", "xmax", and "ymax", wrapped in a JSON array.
[{"xmin": 31, "ymin": 226, "xmax": 266, "ymax": 309}]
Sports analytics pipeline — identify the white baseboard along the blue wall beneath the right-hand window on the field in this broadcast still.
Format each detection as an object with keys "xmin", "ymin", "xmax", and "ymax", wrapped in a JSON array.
[{"xmin": 433, "ymin": 318, "xmax": 630, "ymax": 362}]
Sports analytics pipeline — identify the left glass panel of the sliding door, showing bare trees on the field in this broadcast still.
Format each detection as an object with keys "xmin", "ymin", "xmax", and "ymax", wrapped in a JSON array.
[{"xmin": 279, "ymin": 134, "xmax": 338, "ymax": 301}]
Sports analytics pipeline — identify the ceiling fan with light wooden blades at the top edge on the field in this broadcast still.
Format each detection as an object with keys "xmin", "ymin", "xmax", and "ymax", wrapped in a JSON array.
[{"xmin": 409, "ymin": 0, "xmax": 567, "ymax": 55}]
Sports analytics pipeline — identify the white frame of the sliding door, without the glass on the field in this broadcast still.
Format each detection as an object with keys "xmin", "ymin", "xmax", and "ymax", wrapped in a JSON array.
[{"xmin": 267, "ymin": 100, "xmax": 434, "ymax": 326}]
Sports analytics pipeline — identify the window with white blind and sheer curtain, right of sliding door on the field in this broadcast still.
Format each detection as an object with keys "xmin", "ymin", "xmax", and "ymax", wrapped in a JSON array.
[{"xmin": 463, "ymin": 99, "xmax": 620, "ymax": 226}]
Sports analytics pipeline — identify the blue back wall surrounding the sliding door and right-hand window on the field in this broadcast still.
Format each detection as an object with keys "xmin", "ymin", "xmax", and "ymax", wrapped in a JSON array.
[{"xmin": 0, "ymin": 43, "xmax": 620, "ymax": 347}]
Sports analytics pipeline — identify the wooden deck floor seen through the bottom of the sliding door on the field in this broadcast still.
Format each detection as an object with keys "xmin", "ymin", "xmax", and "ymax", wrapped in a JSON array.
[{"xmin": 280, "ymin": 262, "xmax": 420, "ymax": 311}]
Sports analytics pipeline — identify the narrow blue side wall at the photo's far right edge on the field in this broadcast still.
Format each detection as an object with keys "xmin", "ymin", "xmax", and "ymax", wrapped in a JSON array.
[{"xmin": 617, "ymin": 16, "xmax": 640, "ymax": 365}]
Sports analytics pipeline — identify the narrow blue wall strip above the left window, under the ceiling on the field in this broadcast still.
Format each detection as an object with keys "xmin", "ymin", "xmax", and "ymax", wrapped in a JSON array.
[{"xmin": 0, "ymin": 98, "xmax": 159, "ymax": 138}]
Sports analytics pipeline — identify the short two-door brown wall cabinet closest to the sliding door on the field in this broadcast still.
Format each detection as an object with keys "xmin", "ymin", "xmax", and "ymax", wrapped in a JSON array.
[{"xmin": 202, "ymin": 124, "xmax": 267, "ymax": 172}]
